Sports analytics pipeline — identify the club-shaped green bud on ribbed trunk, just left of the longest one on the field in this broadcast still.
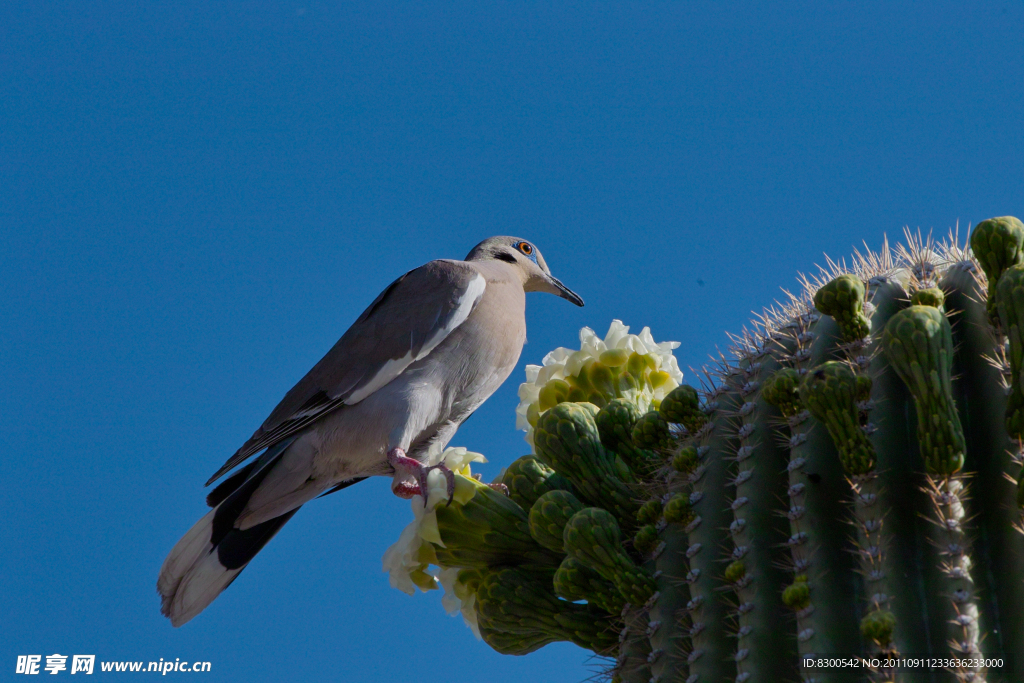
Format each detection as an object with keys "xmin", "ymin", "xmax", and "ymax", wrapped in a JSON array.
[{"xmin": 800, "ymin": 362, "xmax": 876, "ymax": 475}]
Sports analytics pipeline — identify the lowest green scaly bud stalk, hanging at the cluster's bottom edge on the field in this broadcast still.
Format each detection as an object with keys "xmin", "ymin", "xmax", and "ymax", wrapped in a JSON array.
[{"xmin": 476, "ymin": 568, "xmax": 617, "ymax": 654}]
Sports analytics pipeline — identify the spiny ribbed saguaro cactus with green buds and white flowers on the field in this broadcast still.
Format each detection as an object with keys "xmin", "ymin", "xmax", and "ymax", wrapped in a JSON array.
[{"xmin": 385, "ymin": 217, "xmax": 1024, "ymax": 683}]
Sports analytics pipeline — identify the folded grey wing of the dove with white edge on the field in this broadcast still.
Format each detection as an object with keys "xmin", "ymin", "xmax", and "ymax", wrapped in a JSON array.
[{"xmin": 207, "ymin": 260, "xmax": 486, "ymax": 485}]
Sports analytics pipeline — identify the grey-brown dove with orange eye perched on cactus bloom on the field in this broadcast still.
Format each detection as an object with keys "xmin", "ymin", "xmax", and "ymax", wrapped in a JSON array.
[{"xmin": 157, "ymin": 237, "xmax": 584, "ymax": 627}]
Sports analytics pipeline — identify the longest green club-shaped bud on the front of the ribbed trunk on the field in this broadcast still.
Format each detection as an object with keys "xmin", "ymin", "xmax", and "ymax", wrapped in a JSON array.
[{"xmin": 882, "ymin": 306, "xmax": 962, "ymax": 474}]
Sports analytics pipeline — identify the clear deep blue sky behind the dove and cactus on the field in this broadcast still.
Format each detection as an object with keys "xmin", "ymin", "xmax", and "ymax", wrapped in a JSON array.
[{"xmin": 0, "ymin": 0, "xmax": 1024, "ymax": 683}]
